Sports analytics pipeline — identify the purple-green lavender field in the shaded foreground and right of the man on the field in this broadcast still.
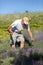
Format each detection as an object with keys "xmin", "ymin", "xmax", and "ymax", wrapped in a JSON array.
[{"xmin": 0, "ymin": 30, "xmax": 43, "ymax": 65}]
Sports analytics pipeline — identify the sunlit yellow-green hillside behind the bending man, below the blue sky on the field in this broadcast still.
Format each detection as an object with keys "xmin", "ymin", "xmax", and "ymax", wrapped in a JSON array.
[{"xmin": 0, "ymin": 12, "xmax": 43, "ymax": 38}]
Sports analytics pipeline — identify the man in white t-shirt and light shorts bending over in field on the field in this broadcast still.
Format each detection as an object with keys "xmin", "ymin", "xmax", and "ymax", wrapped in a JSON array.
[{"xmin": 8, "ymin": 17, "xmax": 34, "ymax": 48}]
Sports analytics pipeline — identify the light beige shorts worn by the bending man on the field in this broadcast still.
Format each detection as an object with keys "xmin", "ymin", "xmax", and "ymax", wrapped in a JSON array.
[{"xmin": 10, "ymin": 32, "xmax": 24, "ymax": 44}]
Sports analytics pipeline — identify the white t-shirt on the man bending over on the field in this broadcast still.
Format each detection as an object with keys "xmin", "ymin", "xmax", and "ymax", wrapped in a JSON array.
[{"xmin": 11, "ymin": 19, "xmax": 30, "ymax": 31}]
